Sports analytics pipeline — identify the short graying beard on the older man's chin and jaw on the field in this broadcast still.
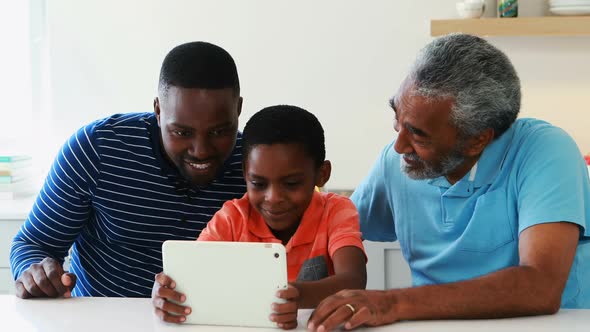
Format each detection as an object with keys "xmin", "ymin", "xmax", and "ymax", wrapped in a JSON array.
[{"xmin": 402, "ymin": 149, "xmax": 465, "ymax": 180}]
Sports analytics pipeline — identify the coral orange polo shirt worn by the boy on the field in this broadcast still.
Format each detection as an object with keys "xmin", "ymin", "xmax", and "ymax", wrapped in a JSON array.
[{"xmin": 198, "ymin": 192, "xmax": 364, "ymax": 282}]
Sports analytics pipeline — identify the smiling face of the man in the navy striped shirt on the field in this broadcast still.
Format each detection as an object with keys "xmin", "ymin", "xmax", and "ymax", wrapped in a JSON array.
[{"xmin": 154, "ymin": 86, "xmax": 242, "ymax": 187}]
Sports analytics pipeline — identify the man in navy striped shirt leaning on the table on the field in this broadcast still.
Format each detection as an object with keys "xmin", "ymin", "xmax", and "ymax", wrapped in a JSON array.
[{"xmin": 10, "ymin": 42, "xmax": 245, "ymax": 298}]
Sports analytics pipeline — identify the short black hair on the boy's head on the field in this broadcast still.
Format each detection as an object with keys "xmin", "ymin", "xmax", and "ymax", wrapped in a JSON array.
[{"xmin": 242, "ymin": 105, "xmax": 326, "ymax": 167}]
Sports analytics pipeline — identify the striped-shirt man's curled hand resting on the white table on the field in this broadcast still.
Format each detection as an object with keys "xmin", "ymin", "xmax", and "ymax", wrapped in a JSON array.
[{"xmin": 14, "ymin": 257, "xmax": 76, "ymax": 299}]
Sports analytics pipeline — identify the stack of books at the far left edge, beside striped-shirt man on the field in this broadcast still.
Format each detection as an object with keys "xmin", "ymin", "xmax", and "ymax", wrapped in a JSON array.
[{"xmin": 0, "ymin": 155, "xmax": 35, "ymax": 199}]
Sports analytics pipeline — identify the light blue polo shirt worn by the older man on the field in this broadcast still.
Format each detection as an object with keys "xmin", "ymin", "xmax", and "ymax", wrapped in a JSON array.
[{"xmin": 351, "ymin": 119, "xmax": 590, "ymax": 308}]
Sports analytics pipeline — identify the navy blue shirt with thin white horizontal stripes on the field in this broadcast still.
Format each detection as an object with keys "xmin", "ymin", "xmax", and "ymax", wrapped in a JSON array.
[{"xmin": 10, "ymin": 113, "xmax": 246, "ymax": 297}]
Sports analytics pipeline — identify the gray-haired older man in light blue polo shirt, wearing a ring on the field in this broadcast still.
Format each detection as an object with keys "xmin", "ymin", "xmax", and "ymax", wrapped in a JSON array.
[{"xmin": 309, "ymin": 35, "xmax": 590, "ymax": 331}]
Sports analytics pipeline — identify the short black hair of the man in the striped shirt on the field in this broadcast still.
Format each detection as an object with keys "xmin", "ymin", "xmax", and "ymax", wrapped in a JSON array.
[{"xmin": 158, "ymin": 41, "xmax": 240, "ymax": 96}]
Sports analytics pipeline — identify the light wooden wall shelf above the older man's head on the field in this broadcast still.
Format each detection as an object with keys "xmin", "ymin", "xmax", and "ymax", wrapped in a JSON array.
[{"xmin": 430, "ymin": 16, "xmax": 590, "ymax": 36}]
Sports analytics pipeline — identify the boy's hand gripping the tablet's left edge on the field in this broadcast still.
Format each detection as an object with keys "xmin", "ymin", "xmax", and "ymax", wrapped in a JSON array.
[{"xmin": 152, "ymin": 272, "xmax": 191, "ymax": 324}]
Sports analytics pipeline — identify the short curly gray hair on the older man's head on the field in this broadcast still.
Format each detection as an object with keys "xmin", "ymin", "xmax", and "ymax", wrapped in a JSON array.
[{"xmin": 409, "ymin": 34, "xmax": 520, "ymax": 138}]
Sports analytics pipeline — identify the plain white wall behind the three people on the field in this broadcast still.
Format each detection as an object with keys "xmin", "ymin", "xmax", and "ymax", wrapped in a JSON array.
[{"xmin": 41, "ymin": 0, "xmax": 590, "ymax": 188}]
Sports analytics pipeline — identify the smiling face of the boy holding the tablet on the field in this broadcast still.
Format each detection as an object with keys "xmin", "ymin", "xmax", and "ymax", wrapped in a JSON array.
[{"xmin": 244, "ymin": 144, "xmax": 330, "ymax": 232}]
